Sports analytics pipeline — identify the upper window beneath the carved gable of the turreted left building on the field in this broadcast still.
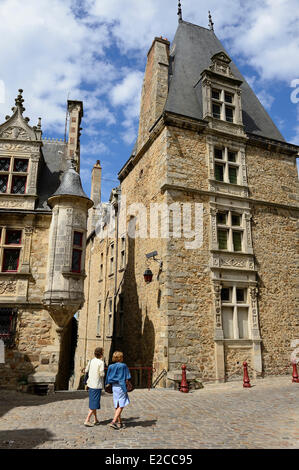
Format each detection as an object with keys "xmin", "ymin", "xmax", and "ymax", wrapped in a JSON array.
[{"xmin": 0, "ymin": 156, "xmax": 29, "ymax": 194}]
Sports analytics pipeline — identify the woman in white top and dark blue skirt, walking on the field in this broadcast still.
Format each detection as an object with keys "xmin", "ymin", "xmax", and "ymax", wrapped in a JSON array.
[{"xmin": 84, "ymin": 348, "xmax": 105, "ymax": 426}]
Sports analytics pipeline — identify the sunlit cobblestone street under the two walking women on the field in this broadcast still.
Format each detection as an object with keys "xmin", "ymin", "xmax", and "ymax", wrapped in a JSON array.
[{"xmin": 0, "ymin": 376, "xmax": 299, "ymax": 449}]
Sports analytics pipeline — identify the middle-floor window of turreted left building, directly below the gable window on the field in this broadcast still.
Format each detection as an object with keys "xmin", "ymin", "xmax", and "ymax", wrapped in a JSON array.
[{"xmin": 0, "ymin": 227, "xmax": 23, "ymax": 273}]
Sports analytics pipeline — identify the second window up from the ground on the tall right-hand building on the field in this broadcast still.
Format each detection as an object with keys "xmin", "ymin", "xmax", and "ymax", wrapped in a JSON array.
[{"xmin": 217, "ymin": 210, "xmax": 244, "ymax": 252}]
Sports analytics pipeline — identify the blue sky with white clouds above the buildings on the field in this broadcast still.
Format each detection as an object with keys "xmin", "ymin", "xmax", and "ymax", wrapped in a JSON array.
[{"xmin": 0, "ymin": 0, "xmax": 299, "ymax": 201}]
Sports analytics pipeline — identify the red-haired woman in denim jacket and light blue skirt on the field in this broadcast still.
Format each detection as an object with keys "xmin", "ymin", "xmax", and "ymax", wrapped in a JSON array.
[{"xmin": 105, "ymin": 351, "xmax": 131, "ymax": 429}]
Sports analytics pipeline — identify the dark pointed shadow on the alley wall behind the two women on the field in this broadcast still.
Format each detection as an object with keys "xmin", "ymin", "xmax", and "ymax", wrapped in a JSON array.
[{"xmin": 109, "ymin": 219, "xmax": 155, "ymax": 388}]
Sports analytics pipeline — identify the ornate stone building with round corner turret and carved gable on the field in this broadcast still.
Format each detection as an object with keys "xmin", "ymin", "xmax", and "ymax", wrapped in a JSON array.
[{"xmin": 0, "ymin": 90, "xmax": 93, "ymax": 391}]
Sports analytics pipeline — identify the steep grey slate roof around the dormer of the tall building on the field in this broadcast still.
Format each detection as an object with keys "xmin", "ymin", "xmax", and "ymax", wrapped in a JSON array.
[{"xmin": 165, "ymin": 21, "xmax": 285, "ymax": 142}]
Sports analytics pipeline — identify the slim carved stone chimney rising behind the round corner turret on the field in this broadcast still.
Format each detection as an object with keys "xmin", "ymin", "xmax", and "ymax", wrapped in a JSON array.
[{"xmin": 67, "ymin": 100, "xmax": 83, "ymax": 172}]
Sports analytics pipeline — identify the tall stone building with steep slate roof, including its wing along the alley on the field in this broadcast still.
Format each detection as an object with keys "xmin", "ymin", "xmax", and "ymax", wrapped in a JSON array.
[{"xmin": 75, "ymin": 18, "xmax": 299, "ymax": 386}]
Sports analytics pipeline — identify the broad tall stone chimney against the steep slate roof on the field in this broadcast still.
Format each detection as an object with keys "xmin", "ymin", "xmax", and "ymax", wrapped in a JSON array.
[{"xmin": 137, "ymin": 37, "xmax": 170, "ymax": 152}]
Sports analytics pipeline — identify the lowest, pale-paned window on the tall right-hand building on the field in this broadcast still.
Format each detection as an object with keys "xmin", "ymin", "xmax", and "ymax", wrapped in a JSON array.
[{"xmin": 221, "ymin": 285, "xmax": 250, "ymax": 339}]
